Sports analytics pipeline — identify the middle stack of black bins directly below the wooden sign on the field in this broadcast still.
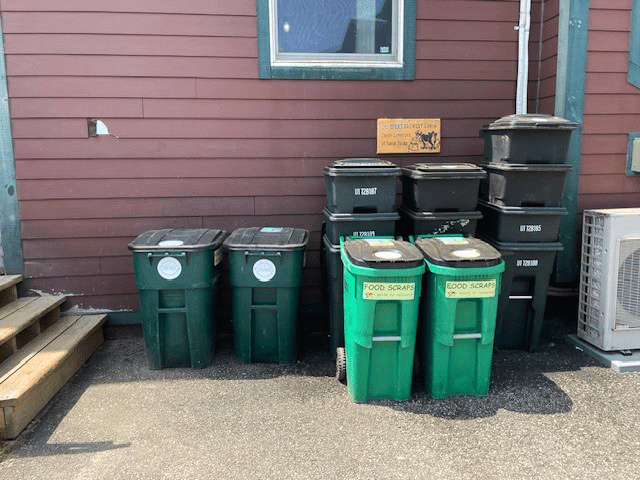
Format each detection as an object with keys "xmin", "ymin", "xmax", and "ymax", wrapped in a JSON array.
[{"xmin": 398, "ymin": 163, "xmax": 487, "ymax": 237}]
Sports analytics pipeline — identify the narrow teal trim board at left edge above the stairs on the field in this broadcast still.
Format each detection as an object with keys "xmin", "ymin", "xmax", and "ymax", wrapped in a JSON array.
[{"xmin": 0, "ymin": 16, "xmax": 24, "ymax": 274}]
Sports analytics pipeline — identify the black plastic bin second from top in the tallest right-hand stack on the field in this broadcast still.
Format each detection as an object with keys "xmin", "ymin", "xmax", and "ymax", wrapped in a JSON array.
[{"xmin": 480, "ymin": 163, "xmax": 571, "ymax": 207}]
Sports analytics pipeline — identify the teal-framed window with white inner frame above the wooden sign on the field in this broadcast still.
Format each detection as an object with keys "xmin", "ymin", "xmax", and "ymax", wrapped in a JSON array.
[{"xmin": 258, "ymin": 0, "xmax": 415, "ymax": 80}]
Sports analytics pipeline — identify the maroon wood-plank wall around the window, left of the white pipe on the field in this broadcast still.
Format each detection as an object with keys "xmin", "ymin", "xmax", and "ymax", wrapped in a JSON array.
[{"xmin": 0, "ymin": 0, "xmax": 519, "ymax": 310}]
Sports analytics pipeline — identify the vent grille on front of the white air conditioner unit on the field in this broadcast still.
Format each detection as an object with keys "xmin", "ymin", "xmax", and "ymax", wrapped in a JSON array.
[{"xmin": 615, "ymin": 238, "xmax": 640, "ymax": 329}]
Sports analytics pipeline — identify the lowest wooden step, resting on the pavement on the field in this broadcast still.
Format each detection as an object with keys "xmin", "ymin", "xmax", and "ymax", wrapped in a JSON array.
[{"xmin": 0, "ymin": 314, "xmax": 107, "ymax": 439}]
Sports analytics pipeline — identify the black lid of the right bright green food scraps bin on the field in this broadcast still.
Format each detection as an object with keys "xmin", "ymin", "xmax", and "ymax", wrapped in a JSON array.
[{"xmin": 416, "ymin": 235, "xmax": 502, "ymax": 268}]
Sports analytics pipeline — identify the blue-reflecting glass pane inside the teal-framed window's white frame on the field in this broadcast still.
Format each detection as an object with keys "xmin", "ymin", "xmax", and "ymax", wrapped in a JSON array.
[{"xmin": 278, "ymin": 0, "xmax": 393, "ymax": 54}]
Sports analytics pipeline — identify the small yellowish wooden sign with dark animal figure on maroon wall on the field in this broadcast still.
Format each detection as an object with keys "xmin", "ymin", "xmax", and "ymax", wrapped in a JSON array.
[{"xmin": 378, "ymin": 118, "xmax": 440, "ymax": 153}]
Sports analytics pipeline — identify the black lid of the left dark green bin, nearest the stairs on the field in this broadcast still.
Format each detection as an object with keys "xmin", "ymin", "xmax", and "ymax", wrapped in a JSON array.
[{"xmin": 129, "ymin": 228, "xmax": 227, "ymax": 252}]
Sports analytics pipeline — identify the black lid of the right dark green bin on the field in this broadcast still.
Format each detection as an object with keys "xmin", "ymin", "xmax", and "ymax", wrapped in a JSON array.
[{"xmin": 224, "ymin": 227, "xmax": 309, "ymax": 251}]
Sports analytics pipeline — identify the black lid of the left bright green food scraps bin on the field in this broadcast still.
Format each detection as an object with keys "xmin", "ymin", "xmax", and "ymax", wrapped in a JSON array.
[{"xmin": 344, "ymin": 238, "xmax": 424, "ymax": 268}]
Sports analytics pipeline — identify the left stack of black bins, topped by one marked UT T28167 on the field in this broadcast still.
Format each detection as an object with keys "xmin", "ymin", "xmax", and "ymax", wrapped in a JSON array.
[{"xmin": 322, "ymin": 158, "xmax": 400, "ymax": 355}]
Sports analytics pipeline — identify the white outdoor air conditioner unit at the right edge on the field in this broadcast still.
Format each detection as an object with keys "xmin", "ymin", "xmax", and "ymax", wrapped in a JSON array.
[{"xmin": 578, "ymin": 208, "xmax": 640, "ymax": 351}]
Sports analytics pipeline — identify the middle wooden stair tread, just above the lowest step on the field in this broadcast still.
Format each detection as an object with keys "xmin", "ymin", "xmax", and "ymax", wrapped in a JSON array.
[{"xmin": 0, "ymin": 295, "xmax": 66, "ymax": 345}]
